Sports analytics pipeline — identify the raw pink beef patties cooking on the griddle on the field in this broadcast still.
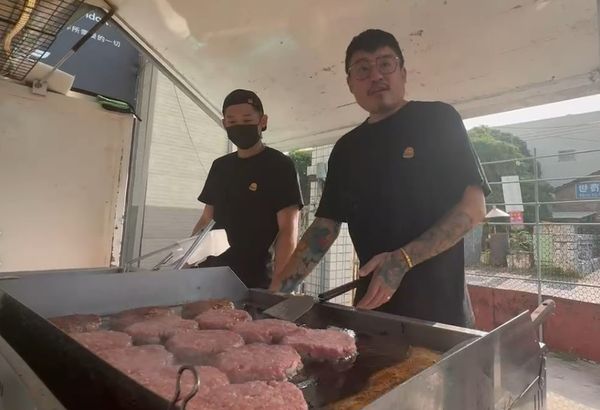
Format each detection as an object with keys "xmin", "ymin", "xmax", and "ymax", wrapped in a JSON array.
[{"xmin": 51, "ymin": 300, "xmax": 357, "ymax": 410}]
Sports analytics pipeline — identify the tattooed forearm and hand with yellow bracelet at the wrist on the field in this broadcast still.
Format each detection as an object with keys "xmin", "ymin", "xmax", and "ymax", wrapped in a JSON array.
[{"xmin": 357, "ymin": 186, "xmax": 485, "ymax": 309}]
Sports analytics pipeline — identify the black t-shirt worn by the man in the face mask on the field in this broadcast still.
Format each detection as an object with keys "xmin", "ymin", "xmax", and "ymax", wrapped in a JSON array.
[{"xmin": 198, "ymin": 147, "xmax": 303, "ymax": 288}]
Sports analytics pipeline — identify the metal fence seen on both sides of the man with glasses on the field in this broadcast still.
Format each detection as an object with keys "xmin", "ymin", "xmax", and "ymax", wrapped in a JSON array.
[{"xmin": 303, "ymin": 143, "xmax": 600, "ymax": 310}]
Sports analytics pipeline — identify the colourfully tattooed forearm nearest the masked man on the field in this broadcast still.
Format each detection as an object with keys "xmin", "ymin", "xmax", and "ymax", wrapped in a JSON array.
[{"xmin": 269, "ymin": 218, "xmax": 341, "ymax": 293}]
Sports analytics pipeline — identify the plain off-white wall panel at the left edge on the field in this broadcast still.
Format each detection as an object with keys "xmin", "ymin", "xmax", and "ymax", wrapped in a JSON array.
[{"xmin": 0, "ymin": 80, "xmax": 133, "ymax": 272}]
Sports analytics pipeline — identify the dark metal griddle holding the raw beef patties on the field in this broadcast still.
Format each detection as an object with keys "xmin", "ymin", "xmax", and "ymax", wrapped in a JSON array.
[{"xmin": 0, "ymin": 268, "xmax": 502, "ymax": 410}]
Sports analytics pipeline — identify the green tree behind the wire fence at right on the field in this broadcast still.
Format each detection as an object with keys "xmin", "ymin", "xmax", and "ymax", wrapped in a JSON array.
[{"xmin": 469, "ymin": 127, "xmax": 553, "ymax": 222}]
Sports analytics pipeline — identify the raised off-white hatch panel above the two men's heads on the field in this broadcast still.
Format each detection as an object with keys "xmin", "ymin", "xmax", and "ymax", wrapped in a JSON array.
[{"xmin": 88, "ymin": 0, "xmax": 600, "ymax": 150}]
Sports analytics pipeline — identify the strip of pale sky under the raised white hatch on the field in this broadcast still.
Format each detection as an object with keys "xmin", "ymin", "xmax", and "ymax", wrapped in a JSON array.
[{"xmin": 464, "ymin": 94, "xmax": 600, "ymax": 129}]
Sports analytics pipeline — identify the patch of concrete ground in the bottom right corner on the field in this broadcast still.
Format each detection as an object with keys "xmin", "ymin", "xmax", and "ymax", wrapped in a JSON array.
[{"xmin": 546, "ymin": 353, "xmax": 600, "ymax": 410}]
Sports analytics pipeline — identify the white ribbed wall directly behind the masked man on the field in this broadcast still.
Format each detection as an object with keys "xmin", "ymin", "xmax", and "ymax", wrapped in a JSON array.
[{"xmin": 142, "ymin": 74, "xmax": 228, "ymax": 266}]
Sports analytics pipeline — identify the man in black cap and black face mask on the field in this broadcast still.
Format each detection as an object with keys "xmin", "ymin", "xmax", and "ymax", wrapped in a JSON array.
[{"xmin": 192, "ymin": 90, "xmax": 303, "ymax": 288}]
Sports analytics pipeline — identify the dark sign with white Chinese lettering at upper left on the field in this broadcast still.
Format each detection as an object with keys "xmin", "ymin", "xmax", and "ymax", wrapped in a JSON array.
[{"xmin": 34, "ymin": 7, "xmax": 140, "ymax": 107}]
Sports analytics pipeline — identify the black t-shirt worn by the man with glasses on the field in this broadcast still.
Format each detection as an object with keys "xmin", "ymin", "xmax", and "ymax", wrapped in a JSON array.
[{"xmin": 316, "ymin": 101, "xmax": 489, "ymax": 326}]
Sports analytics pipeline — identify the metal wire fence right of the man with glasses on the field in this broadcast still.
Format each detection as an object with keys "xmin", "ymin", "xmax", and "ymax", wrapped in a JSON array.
[{"xmin": 465, "ymin": 149, "xmax": 600, "ymax": 326}]
